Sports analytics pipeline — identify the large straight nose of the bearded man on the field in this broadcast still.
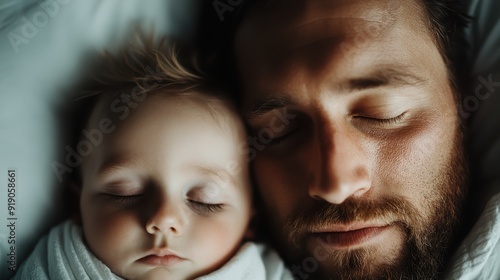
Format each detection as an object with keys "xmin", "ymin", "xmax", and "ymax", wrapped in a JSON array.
[{"xmin": 309, "ymin": 120, "xmax": 371, "ymax": 204}]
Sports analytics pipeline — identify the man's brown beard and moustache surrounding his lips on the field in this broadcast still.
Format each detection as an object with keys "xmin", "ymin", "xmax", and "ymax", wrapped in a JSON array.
[{"xmin": 276, "ymin": 128, "xmax": 468, "ymax": 279}]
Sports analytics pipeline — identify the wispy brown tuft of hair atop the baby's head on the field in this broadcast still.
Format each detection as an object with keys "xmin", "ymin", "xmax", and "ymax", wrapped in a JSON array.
[{"xmin": 81, "ymin": 32, "xmax": 222, "ymax": 99}]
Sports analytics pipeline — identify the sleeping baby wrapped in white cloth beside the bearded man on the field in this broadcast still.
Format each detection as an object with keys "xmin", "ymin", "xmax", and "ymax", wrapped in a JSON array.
[{"xmin": 14, "ymin": 36, "xmax": 293, "ymax": 280}]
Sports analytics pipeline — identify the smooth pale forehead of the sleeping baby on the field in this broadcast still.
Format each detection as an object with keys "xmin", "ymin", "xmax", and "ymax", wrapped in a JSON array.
[{"xmin": 82, "ymin": 87, "xmax": 246, "ymax": 162}]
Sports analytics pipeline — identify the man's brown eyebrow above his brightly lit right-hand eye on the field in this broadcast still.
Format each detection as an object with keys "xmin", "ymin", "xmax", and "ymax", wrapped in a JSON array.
[{"xmin": 348, "ymin": 65, "xmax": 427, "ymax": 92}]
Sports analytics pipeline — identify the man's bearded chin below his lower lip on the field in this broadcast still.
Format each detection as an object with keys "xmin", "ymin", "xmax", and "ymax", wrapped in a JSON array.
[{"xmin": 285, "ymin": 222, "xmax": 452, "ymax": 279}]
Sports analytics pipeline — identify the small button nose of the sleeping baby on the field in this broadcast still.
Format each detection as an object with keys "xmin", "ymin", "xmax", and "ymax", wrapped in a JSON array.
[{"xmin": 146, "ymin": 199, "xmax": 188, "ymax": 236}]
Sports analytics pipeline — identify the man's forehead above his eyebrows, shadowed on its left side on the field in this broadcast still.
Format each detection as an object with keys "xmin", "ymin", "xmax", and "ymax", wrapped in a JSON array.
[{"xmin": 235, "ymin": 0, "xmax": 433, "ymax": 84}]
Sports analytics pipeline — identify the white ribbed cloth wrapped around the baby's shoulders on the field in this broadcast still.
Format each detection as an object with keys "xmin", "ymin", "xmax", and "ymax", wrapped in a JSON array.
[{"xmin": 13, "ymin": 221, "xmax": 293, "ymax": 280}]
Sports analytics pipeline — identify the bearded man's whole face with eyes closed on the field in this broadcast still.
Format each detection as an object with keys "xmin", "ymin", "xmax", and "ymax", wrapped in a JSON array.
[{"xmin": 235, "ymin": 0, "xmax": 465, "ymax": 279}]
